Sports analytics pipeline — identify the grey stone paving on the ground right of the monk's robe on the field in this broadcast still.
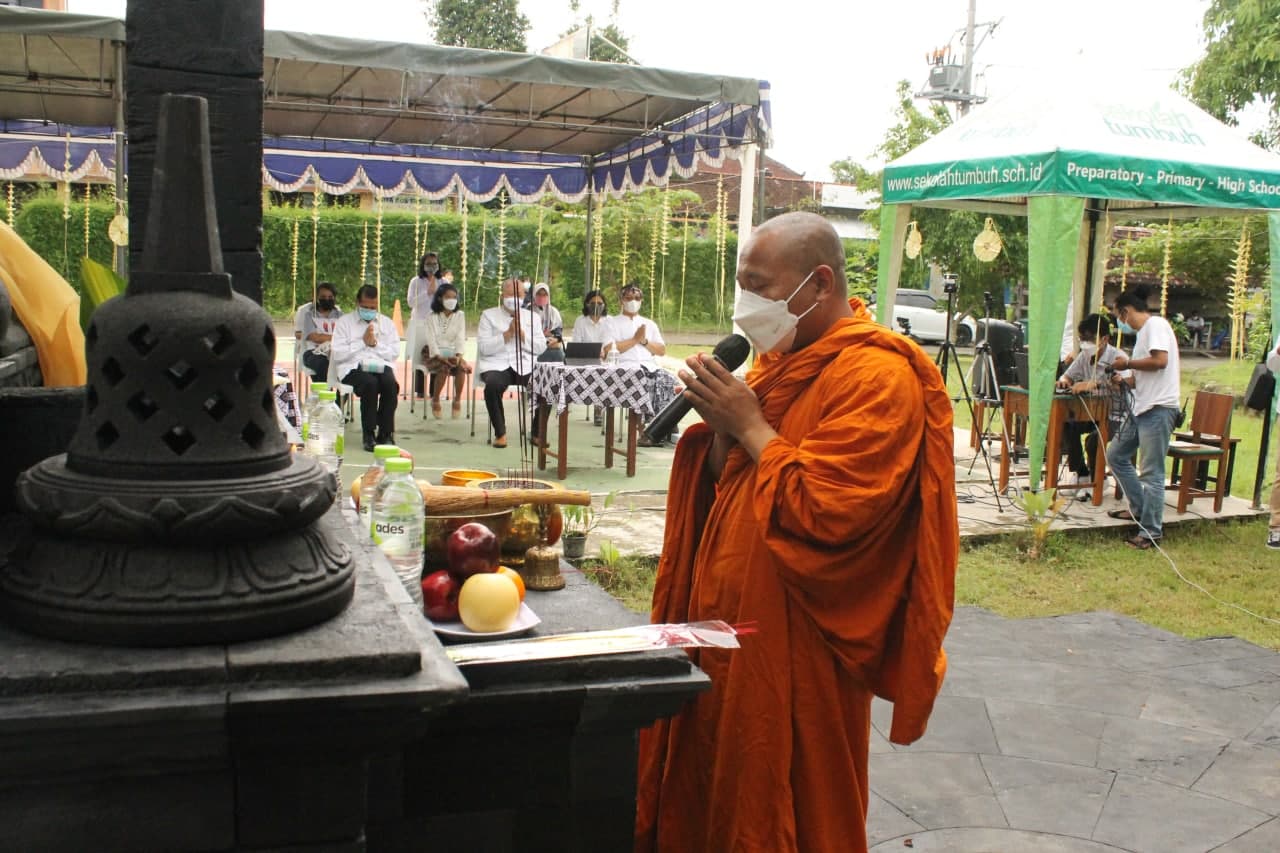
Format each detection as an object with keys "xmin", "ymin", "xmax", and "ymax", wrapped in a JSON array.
[{"xmin": 868, "ymin": 607, "xmax": 1280, "ymax": 853}]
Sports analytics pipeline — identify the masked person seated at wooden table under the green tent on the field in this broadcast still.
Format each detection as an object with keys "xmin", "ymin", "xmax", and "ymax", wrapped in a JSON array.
[{"xmin": 1057, "ymin": 314, "xmax": 1128, "ymax": 501}]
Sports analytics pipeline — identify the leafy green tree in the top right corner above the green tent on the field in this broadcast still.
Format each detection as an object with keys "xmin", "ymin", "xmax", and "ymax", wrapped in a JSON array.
[{"xmin": 1183, "ymin": 0, "xmax": 1280, "ymax": 147}]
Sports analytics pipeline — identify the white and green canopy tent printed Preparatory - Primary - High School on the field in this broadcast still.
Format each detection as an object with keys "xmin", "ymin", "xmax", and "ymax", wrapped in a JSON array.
[{"xmin": 877, "ymin": 73, "xmax": 1280, "ymax": 489}]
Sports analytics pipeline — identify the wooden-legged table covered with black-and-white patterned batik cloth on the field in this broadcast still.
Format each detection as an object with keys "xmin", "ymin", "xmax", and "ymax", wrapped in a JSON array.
[{"xmin": 529, "ymin": 361, "xmax": 676, "ymax": 480}]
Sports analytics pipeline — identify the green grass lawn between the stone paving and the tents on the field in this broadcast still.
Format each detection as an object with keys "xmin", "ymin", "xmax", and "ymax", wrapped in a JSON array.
[{"xmin": 582, "ymin": 519, "xmax": 1280, "ymax": 651}]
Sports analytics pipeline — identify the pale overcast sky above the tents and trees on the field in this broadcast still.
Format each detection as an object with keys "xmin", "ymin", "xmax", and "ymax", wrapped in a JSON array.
[{"xmin": 68, "ymin": 0, "xmax": 1208, "ymax": 179}]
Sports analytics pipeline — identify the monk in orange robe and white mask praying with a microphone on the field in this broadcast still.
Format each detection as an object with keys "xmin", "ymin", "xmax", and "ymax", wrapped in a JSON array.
[{"xmin": 635, "ymin": 213, "xmax": 959, "ymax": 853}]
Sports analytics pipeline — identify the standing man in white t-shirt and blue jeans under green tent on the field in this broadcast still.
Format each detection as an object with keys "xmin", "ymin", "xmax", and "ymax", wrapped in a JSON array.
[{"xmin": 1107, "ymin": 286, "xmax": 1181, "ymax": 551}]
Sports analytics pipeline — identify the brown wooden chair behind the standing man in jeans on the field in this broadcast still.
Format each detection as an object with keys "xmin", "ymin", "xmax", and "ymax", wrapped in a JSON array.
[{"xmin": 1165, "ymin": 391, "xmax": 1235, "ymax": 514}]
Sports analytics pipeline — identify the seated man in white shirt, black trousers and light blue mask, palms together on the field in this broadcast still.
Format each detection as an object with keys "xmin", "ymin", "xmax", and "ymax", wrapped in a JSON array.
[{"xmin": 333, "ymin": 284, "xmax": 399, "ymax": 451}]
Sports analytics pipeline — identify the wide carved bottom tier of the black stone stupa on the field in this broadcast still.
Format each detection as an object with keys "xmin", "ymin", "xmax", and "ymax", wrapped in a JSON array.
[{"xmin": 0, "ymin": 520, "xmax": 355, "ymax": 646}]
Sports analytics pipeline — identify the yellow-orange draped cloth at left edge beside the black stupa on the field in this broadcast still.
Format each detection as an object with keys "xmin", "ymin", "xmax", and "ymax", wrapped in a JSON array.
[{"xmin": 0, "ymin": 223, "xmax": 86, "ymax": 387}]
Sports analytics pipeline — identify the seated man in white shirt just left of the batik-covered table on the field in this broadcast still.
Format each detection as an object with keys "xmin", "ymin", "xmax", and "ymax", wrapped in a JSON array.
[{"xmin": 476, "ymin": 278, "xmax": 547, "ymax": 447}]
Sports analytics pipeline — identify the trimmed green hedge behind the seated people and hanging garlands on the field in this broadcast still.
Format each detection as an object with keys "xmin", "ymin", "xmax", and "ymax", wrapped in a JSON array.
[{"xmin": 14, "ymin": 193, "xmax": 737, "ymax": 328}]
